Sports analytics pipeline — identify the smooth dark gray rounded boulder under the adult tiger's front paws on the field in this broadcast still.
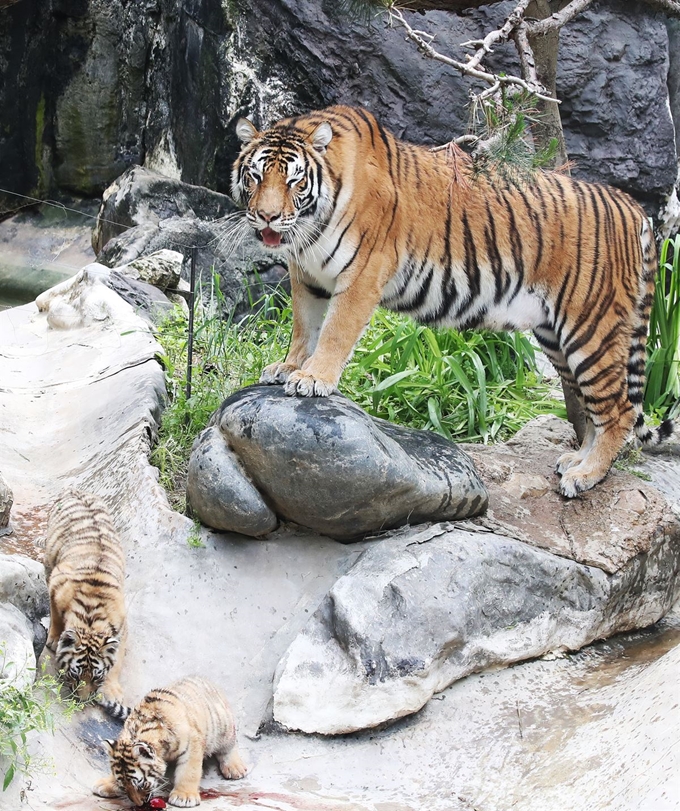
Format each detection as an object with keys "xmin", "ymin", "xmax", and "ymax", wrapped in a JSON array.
[{"xmin": 187, "ymin": 386, "xmax": 487, "ymax": 540}]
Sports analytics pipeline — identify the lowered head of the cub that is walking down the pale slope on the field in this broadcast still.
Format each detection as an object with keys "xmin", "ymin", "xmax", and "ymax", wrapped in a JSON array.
[{"xmin": 57, "ymin": 628, "xmax": 120, "ymax": 701}]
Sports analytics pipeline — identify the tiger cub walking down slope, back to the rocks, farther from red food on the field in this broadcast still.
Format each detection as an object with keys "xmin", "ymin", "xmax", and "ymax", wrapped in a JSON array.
[{"xmin": 44, "ymin": 490, "xmax": 129, "ymax": 718}]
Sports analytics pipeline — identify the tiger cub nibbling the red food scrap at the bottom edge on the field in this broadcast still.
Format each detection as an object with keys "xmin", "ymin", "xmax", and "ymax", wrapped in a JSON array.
[{"xmin": 93, "ymin": 676, "xmax": 247, "ymax": 808}]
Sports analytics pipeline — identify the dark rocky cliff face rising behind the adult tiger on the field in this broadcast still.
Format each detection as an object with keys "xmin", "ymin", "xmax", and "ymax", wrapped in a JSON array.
[{"xmin": 0, "ymin": 0, "xmax": 680, "ymax": 222}]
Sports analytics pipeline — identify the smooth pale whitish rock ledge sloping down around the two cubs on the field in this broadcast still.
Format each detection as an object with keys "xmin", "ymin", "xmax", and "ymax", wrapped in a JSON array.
[{"xmin": 0, "ymin": 268, "xmax": 680, "ymax": 811}]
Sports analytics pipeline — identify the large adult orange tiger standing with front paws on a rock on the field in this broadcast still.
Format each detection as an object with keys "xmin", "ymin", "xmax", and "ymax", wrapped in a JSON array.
[{"xmin": 232, "ymin": 106, "xmax": 673, "ymax": 497}]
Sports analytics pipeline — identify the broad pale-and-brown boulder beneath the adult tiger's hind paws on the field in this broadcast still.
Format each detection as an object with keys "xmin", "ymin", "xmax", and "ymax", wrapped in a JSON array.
[{"xmin": 273, "ymin": 418, "xmax": 680, "ymax": 735}]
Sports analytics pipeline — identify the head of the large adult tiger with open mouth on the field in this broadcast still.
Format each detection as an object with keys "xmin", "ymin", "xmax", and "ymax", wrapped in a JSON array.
[{"xmin": 232, "ymin": 113, "xmax": 333, "ymax": 249}]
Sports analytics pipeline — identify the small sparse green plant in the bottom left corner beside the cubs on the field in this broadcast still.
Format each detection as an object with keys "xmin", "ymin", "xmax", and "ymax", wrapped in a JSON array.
[{"xmin": 0, "ymin": 643, "xmax": 77, "ymax": 791}]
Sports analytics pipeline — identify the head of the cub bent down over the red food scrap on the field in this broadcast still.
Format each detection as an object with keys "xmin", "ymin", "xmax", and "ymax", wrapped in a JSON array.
[{"xmin": 106, "ymin": 736, "xmax": 166, "ymax": 805}]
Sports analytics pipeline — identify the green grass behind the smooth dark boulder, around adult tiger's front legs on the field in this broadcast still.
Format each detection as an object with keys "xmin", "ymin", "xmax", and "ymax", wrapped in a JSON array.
[{"xmin": 152, "ymin": 288, "xmax": 566, "ymax": 510}]
